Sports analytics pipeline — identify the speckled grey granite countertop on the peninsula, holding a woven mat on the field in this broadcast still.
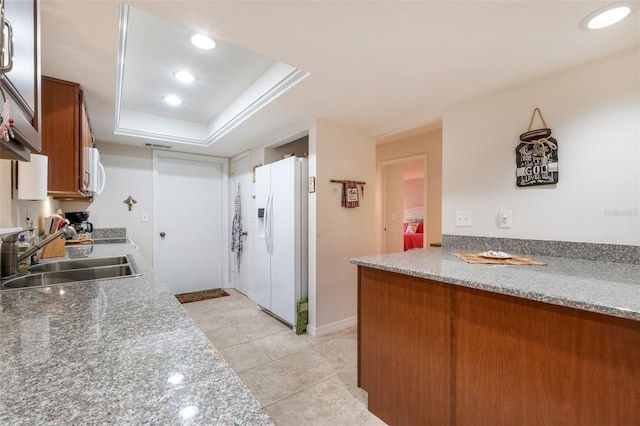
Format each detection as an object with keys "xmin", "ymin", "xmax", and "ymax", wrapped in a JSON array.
[{"xmin": 351, "ymin": 248, "xmax": 640, "ymax": 321}]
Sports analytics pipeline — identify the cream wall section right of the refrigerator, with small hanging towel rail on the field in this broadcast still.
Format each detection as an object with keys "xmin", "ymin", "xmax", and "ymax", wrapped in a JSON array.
[{"xmin": 309, "ymin": 121, "xmax": 376, "ymax": 335}]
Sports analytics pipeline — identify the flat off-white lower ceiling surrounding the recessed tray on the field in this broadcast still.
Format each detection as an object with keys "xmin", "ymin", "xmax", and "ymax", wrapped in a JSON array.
[{"xmin": 41, "ymin": 0, "xmax": 640, "ymax": 157}]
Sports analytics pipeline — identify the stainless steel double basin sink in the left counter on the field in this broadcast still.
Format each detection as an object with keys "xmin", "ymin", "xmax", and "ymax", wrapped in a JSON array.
[{"xmin": 0, "ymin": 254, "xmax": 140, "ymax": 290}]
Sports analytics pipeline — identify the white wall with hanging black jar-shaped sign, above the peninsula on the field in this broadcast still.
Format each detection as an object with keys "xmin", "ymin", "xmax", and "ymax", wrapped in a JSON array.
[{"xmin": 442, "ymin": 50, "xmax": 640, "ymax": 245}]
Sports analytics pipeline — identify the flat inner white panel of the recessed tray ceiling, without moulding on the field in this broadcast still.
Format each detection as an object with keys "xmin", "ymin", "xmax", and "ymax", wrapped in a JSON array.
[{"xmin": 122, "ymin": 8, "xmax": 275, "ymax": 122}]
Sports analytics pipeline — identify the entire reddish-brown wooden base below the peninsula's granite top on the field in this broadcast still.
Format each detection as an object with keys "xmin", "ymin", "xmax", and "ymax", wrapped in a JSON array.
[{"xmin": 358, "ymin": 266, "xmax": 640, "ymax": 426}]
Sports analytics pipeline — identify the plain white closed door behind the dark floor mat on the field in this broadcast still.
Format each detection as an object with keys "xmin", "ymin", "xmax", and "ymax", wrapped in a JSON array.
[{"xmin": 153, "ymin": 151, "xmax": 229, "ymax": 294}]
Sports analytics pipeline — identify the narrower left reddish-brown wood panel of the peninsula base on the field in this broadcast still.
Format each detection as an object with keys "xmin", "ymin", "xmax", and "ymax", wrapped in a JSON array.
[{"xmin": 358, "ymin": 266, "xmax": 452, "ymax": 426}]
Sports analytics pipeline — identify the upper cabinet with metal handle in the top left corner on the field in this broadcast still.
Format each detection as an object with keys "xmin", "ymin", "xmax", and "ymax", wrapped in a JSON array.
[{"xmin": 0, "ymin": 0, "xmax": 41, "ymax": 161}]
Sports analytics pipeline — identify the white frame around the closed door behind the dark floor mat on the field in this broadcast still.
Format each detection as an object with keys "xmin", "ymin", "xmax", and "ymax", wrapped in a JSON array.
[{"xmin": 152, "ymin": 149, "xmax": 232, "ymax": 288}]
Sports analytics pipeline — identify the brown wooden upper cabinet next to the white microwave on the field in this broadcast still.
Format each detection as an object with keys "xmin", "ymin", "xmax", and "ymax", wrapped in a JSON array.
[{"xmin": 42, "ymin": 76, "xmax": 93, "ymax": 200}]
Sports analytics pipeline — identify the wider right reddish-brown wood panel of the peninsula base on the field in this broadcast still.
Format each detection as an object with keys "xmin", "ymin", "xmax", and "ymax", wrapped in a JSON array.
[{"xmin": 453, "ymin": 288, "xmax": 640, "ymax": 426}]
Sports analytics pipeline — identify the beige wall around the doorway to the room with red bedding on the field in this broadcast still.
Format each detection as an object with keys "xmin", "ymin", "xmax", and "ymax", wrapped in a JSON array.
[{"xmin": 376, "ymin": 129, "xmax": 442, "ymax": 244}]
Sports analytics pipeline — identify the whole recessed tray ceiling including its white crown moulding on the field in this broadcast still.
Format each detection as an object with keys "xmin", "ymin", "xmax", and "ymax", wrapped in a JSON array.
[{"xmin": 115, "ymin": 4, "xmax": 308, "ymax": 146}]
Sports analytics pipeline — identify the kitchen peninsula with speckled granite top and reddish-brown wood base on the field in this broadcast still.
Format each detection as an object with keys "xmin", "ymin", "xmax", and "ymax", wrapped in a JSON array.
[{"xmin": 351, "ymin": 247, "xmax": 640, "ymax": 425}]
